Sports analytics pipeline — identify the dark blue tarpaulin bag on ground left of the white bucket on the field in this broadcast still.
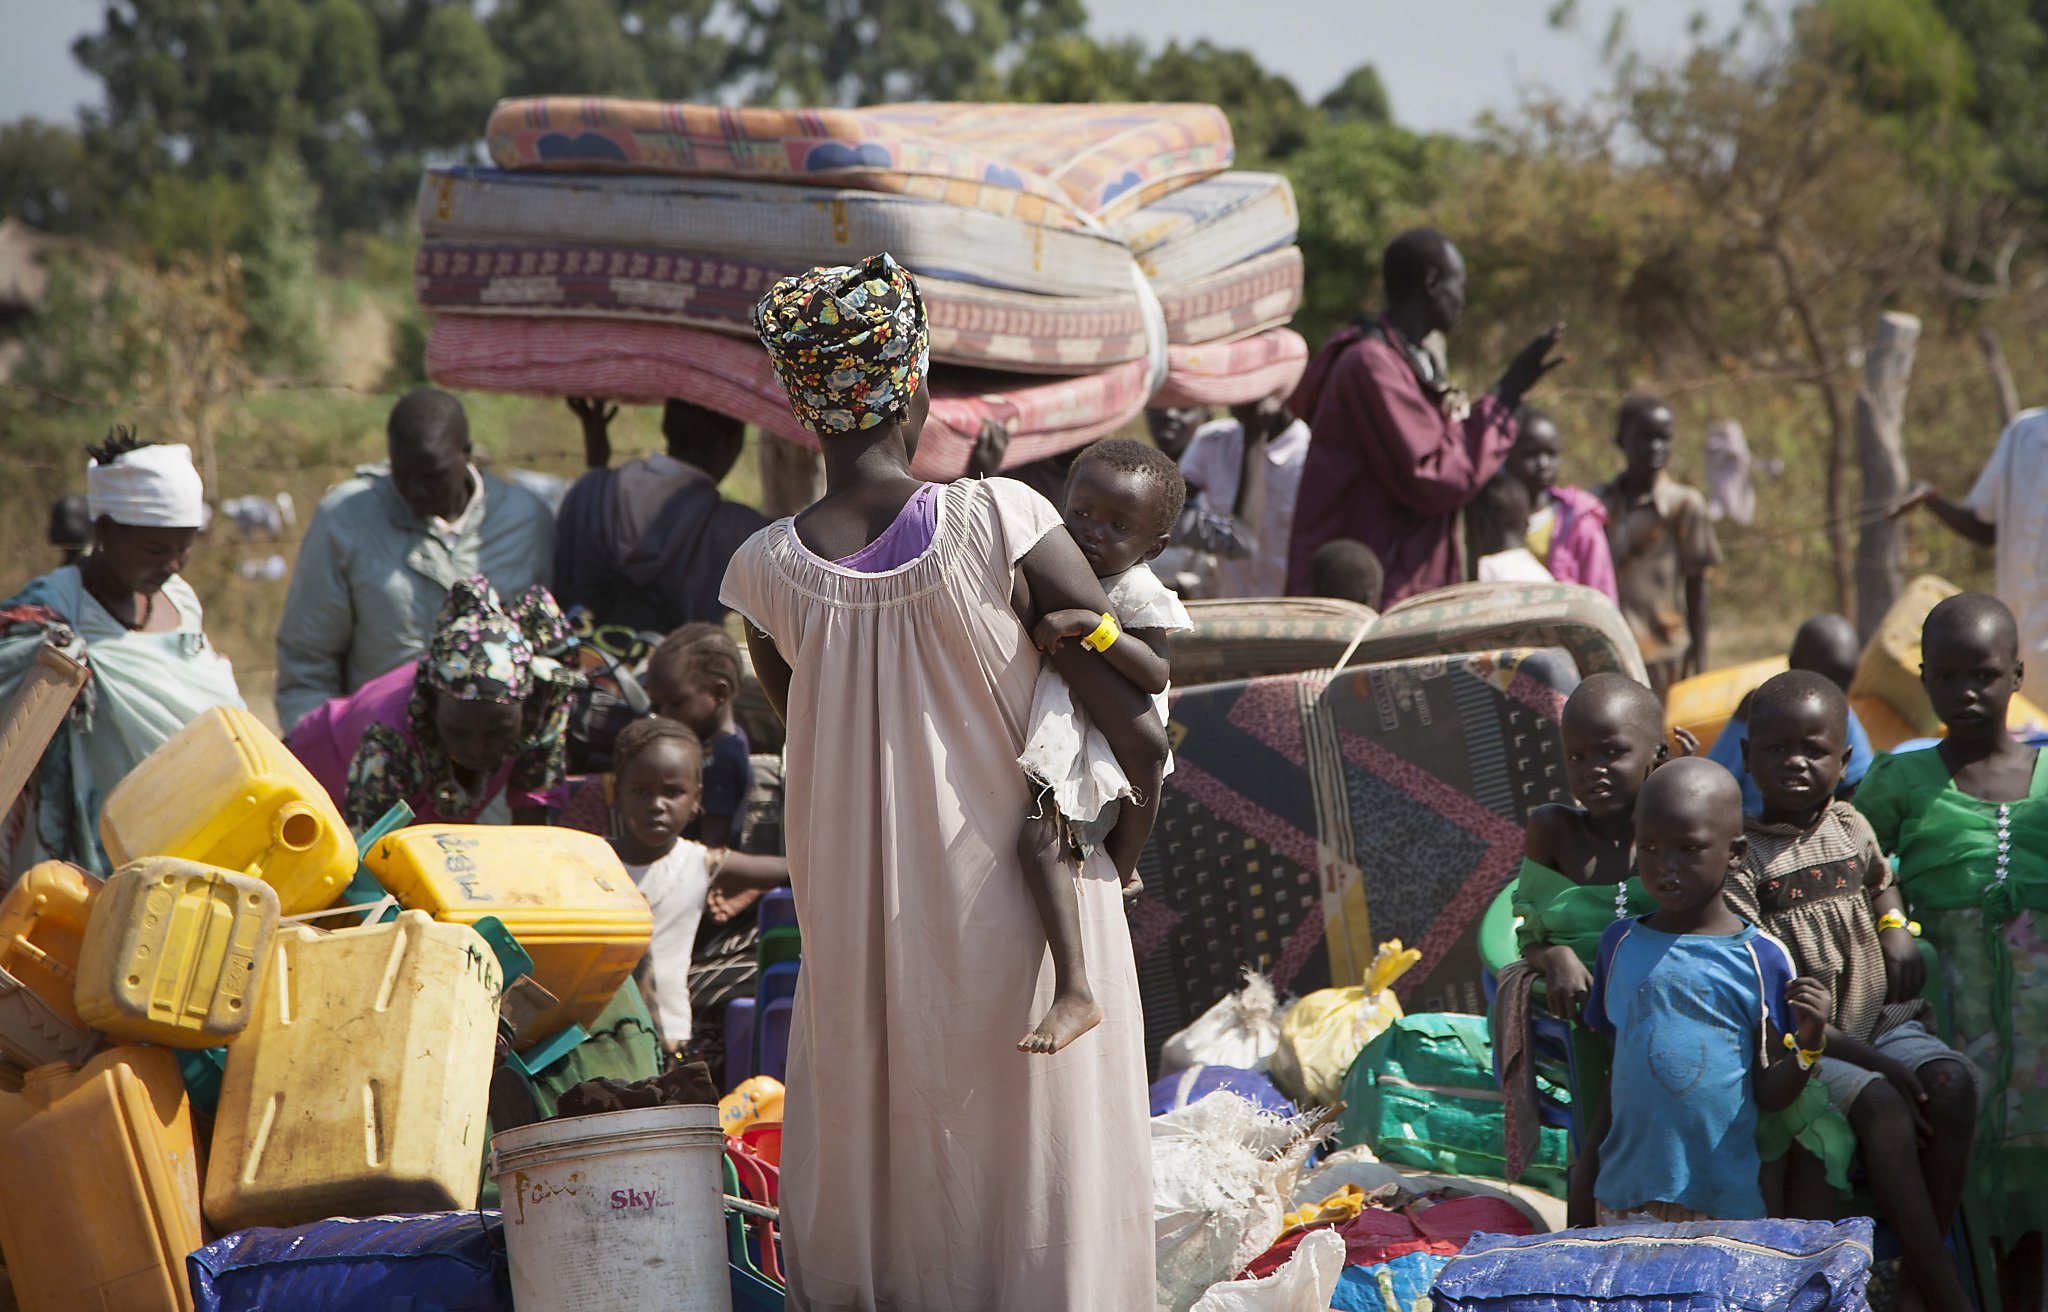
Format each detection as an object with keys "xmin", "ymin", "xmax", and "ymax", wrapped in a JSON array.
[{"xmin": 184, "ymin": 1212, "xmax": 512, "ymax": 1312}]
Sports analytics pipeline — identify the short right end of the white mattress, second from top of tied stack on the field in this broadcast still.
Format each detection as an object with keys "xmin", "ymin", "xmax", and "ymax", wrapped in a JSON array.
[{"xmin": 1110, "ymin": 172, "xmax": 1300, "ymax": 285}]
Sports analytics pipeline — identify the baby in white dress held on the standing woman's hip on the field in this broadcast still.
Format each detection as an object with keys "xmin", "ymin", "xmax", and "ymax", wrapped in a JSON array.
[{"xmin": 1018, "ymin": 438, "xmax": 1194, "ymax": 1052}]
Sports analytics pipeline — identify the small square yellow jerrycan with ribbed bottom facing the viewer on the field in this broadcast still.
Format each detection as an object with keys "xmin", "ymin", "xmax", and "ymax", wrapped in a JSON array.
[{"xmin": 78, "ymin": 856, "xmax": 276, "ymax": 1048}]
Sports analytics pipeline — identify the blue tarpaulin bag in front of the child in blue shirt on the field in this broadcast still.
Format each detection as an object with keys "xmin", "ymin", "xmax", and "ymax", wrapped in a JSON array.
[{"xmin": 1430, "ymin": 1216, "xmax": 1872, "ymax": 1312}]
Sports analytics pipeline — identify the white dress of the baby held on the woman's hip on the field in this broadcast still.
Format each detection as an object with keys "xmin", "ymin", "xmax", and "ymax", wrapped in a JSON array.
[{"xmin": 1018, "ymin": 561, "xmax": 1194, "ymax": 854}]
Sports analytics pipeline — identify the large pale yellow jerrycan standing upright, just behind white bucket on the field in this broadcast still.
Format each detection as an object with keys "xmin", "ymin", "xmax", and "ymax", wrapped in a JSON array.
[{"xmin": 205, "ymin": 911, "xmax": 502, "ymax": 1234}]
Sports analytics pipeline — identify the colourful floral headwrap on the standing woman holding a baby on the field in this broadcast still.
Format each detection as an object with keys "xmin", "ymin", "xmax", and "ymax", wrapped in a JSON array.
[{"xmin": 754, "ymin": 252, "xmax": 932, "ymax": 438}]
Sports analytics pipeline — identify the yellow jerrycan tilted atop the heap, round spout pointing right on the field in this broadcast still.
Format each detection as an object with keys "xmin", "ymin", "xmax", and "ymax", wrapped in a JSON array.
[{"xmin": 100, "ymin": 706, "xmax": 356, "ymax": 915}]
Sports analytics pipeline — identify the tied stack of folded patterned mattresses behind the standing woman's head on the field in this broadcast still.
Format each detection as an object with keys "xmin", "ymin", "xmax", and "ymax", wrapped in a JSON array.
[{"xmin": 414, "ymin": 98, "xmax": 1307, "ymax": 477}]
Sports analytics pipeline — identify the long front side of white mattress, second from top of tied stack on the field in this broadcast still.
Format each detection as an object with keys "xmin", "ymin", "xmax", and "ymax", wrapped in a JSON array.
[{"xmin": 418, "ymin": 168, "xmax": 1130, "ymax": 297}]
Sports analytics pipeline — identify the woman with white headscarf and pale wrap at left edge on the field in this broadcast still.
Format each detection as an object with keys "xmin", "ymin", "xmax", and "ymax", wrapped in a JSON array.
[{"xmin": 0, "ymin": 426, "xmax": 242, "ymax": 886}]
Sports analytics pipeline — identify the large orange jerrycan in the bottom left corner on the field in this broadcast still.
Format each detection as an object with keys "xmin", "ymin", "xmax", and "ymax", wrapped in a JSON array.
[{"xmin": 0, "ymin": 1048, "xmax": 205, "ymax": 1312}]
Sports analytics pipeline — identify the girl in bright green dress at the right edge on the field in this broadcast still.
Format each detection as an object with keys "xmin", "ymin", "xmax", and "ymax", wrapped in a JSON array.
[{"xmin": 1855, "ymin": 592, "xmax": 2048, "ymax": 1308}]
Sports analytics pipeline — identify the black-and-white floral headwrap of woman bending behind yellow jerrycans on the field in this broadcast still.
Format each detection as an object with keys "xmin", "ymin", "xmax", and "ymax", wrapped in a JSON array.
[{"xmin": 420, "ymin": 575, "xmax": 571, "ymax": 702}]
